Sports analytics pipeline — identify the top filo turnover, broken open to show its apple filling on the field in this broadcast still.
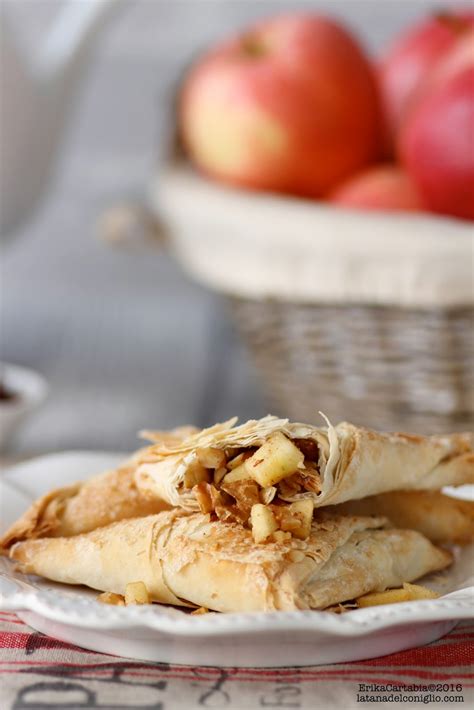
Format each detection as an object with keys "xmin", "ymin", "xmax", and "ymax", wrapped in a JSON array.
[{"xmin": 135, "ymin": 416, "xmax": 474, "ymax": 522}]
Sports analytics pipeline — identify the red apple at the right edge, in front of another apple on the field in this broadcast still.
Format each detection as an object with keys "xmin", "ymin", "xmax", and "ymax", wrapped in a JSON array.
[{"xmin": 399, "ymin": 67, "xmax": 474, "ymax": 219}]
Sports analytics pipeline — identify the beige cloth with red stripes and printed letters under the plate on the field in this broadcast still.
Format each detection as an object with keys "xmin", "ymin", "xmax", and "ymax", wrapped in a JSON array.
[{"xmin": 0, "ymin": 612, "xmax": 474, "ymax": 710}]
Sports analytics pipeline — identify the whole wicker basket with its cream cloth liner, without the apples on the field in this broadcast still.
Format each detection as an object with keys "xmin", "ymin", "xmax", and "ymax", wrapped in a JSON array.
[{"xmin": 152, "ymin": 165, "xmax": 474, "ymax": 433}]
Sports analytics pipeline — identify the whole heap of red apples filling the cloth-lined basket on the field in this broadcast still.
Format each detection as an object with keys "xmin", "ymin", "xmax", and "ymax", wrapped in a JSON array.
[{"xmin": 180, "ymin": 11, "xmax": 474, "ymax": 219}]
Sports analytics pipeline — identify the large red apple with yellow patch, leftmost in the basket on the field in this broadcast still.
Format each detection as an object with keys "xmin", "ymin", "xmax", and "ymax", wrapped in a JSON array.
[{"xmin": 180, "ymin": 14, "xmax": 379, "ymax": 196}]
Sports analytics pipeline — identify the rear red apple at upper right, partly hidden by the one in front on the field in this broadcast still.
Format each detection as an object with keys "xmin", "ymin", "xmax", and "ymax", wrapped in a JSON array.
[{"xmin": 379, "ymin": 11, "xmax": 474, "ymax": 141}]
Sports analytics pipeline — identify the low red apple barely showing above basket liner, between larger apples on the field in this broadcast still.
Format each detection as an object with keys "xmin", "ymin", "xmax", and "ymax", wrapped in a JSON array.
[{"xmin": 329, "ymin": 165, "xmax": 424, "ymax": 212}]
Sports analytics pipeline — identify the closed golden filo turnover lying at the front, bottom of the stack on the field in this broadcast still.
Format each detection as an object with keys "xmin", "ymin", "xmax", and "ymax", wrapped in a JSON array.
[{"xmin": 10, "ymin": 510, "xmax": 451, "ymax": 612}]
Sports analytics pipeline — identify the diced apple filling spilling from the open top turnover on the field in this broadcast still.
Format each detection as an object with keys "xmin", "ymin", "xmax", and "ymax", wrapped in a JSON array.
[{"xmin": 183, "ymin": 432, "xmax": 321, "ymax": 541}]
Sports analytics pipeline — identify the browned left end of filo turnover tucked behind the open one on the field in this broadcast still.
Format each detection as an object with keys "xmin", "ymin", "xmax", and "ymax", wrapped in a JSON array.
[{"xmin": 0, "ymin": 426, "xmax": 197, "ymax": 554}]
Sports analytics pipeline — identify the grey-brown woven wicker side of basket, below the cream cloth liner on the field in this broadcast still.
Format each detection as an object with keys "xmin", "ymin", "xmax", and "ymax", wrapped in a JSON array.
[{"xmin": 231, "ymin": 298, "xmax": 474, "ymax": 433}]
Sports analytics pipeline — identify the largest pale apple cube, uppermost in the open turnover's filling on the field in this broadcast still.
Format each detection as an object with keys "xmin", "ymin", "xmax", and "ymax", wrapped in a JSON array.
[{"xmin": 244, "ymin": 431, "xmax": 304, "ymax": 488}]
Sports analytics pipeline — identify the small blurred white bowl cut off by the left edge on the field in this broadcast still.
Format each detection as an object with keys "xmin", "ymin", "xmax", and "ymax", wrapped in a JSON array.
[{"xmin": 0, "ymin": 362, "xmax": 48, "ymax": 450}]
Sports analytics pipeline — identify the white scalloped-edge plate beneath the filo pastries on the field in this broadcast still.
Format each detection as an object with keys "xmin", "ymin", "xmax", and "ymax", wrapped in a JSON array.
[{"xmin": 0, "ymin": 451, "xmax": 474, "ymax": 666}]
